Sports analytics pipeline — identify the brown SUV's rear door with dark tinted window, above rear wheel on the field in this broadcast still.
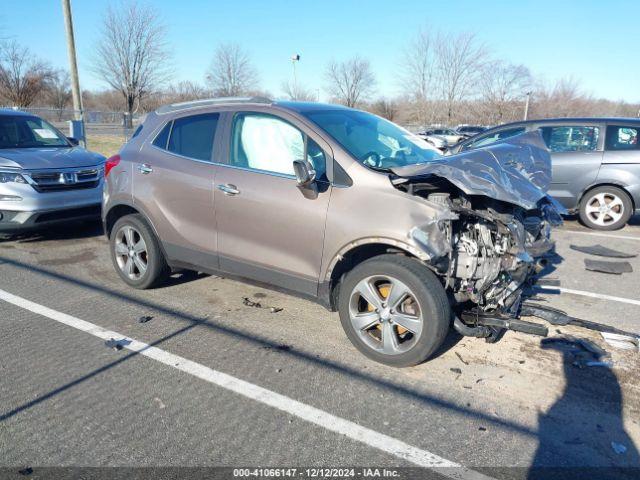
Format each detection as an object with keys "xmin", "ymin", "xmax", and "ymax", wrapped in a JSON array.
[{"xmin": 133, "ymin": 113, "xmax": 219, "ymax": 269}]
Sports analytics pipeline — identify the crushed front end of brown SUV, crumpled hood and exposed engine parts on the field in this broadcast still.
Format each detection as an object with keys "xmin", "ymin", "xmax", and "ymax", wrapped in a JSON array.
[{"xmin": 392, "ymin": 134, "xmax": 563, "ymax": 339}]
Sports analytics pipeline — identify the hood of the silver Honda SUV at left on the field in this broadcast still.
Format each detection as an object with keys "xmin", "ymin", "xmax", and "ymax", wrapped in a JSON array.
[{"xmin": 0, "ymin": 147, "xmax": 105, "ymax": 170}]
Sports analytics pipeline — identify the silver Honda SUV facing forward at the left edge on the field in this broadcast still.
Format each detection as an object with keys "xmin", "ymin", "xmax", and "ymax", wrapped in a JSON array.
[{"xmin": 0, "ymin": 110, "xmax": 105, "ymax": 234}]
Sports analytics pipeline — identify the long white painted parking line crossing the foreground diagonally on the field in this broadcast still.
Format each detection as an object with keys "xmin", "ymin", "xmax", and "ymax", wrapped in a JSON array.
[{"xmin": 0, "ymin": 290, "xmax": 490, "ymax": 480}]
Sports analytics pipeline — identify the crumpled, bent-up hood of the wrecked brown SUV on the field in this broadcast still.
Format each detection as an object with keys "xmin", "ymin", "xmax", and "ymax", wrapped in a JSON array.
[{"xmin": 392, "ymin": 130, "xmax": 557, "ymax": 210}]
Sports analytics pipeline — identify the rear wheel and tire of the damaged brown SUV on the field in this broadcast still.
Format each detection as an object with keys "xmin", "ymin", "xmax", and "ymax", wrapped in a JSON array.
[{"xmin": 109, "ymin": 214, "xmax": 171, "ymax": 290}]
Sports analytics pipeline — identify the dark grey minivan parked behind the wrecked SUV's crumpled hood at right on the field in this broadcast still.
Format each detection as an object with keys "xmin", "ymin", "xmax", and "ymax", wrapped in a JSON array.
[{"xmin": 449, "ymin": 118, "xmax": 640, "ymax": 230}]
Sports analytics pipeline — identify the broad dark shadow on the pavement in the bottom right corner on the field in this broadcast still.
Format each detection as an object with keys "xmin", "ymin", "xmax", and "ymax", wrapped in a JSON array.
[{"xmin": 527, "ymin": 342, "xmax": 640, "ymax": 480}]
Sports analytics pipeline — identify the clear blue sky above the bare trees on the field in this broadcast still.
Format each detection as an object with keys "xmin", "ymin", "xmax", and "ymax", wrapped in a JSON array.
[{"xmin": 0, "ymin": 0, "xmax": 640, "ymax": 102}]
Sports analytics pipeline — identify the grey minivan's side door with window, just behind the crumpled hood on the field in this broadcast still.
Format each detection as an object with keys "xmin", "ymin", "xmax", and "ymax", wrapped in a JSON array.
[{"xmin": 540, "ymin": 124, "xmax": 604, "ymax": 209}]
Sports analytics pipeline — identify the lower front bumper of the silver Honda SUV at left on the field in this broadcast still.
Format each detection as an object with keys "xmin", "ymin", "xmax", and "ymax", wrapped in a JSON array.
[{"xmin": 0, "ymin": 203, "xmax": 101, "ymax": 233}]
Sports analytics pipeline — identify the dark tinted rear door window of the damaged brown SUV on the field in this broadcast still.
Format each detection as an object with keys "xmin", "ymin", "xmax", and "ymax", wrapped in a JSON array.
[{"xmin": 167, "ymin": 113, "xmax": 219, "ymax": 162}]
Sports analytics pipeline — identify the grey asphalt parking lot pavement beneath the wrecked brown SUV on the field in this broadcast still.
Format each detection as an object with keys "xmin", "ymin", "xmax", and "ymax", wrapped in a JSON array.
[{"xmin": 0, "ymin": 221, "xmax": 640, "ymax": 478}]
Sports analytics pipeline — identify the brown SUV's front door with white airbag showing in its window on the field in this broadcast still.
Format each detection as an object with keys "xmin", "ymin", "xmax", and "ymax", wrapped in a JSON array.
[{"xmin": 215, "ymin": 112, "xmax": 331, "ymax": 296}]
